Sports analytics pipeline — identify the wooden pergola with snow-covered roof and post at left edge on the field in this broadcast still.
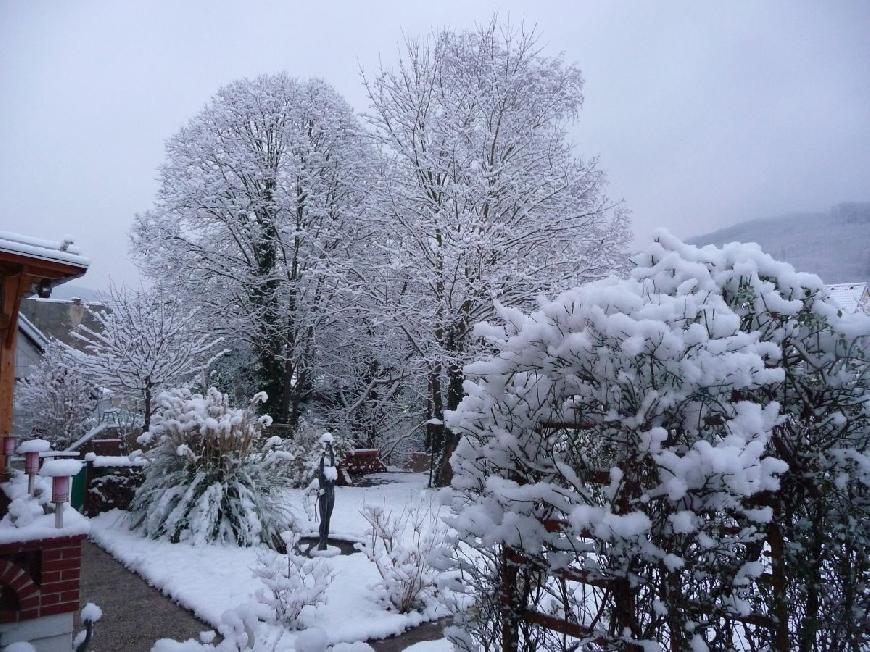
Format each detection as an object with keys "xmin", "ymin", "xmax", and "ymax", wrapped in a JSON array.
[{"xmin": 0, "ymin": 231, "xmax": 89, "ymax": 473}]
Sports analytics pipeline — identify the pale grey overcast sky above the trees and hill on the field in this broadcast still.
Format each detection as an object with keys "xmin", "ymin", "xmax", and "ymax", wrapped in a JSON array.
[{"xmin": 0, "ymin": 0, "xmax": 870, "ymax": 288}]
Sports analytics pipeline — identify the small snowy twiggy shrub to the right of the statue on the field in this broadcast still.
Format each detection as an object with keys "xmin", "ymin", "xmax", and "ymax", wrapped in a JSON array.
[{"xmin": 357, "ymin": 504, "xmax": 446, "ymax": 613}]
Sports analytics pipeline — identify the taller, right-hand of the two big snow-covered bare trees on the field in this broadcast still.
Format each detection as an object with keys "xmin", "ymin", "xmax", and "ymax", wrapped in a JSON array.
[{"xmin": 366, "ymin": 21, "xmax": 627, "ymax": 482}]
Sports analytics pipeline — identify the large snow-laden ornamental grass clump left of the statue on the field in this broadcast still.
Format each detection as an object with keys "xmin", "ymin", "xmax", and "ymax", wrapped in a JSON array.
[{"xmin": 130, "ymin": 388, "xmax": 291, "ymax": 545}]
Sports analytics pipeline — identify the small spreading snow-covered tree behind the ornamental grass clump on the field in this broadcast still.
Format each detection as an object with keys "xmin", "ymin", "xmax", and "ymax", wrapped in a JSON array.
[{"xmin": 67, "ymin": 288, "xmax": 221, "ymax": 430}]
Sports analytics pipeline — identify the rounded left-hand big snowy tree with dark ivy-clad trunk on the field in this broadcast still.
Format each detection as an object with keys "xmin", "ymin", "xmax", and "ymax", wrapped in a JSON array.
[{"xmin": 132, "ymin": 74, "xmax": 374, "ymax": 425}]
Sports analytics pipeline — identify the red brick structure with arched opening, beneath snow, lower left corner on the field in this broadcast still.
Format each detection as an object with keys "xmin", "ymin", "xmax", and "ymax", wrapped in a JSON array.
[{"xmin": 0, "ymin": 534, "xmax": 85, "ymax": 624}]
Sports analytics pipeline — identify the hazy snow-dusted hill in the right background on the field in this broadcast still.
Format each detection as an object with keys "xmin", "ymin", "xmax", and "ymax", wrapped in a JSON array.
[{"xmin": 689, "ymin": 202, "xmax": 870, "ymax": 283}]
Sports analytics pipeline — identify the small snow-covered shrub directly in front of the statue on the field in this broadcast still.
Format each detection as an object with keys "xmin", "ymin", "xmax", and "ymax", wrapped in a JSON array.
[{"xmin": 254, "ymin": 532, "xmax": 334, "ymax": 629}]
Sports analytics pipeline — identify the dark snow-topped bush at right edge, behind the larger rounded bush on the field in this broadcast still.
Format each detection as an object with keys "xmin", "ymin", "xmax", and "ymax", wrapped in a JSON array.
[{"xmin": 635, "ymin": 232, "xmax": 870, "ymax": 650}]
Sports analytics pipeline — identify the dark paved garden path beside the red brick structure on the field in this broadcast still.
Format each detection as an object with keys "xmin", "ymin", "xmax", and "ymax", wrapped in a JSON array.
[{"xmin": 81, "ymin": 541, "xmax": 211, "ymax": 652}]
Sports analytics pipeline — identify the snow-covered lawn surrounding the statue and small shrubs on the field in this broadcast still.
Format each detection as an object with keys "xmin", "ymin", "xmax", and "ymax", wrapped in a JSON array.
[{"xmin": 91, "ymin": 473, "xmax": 454, "ymax": 652}]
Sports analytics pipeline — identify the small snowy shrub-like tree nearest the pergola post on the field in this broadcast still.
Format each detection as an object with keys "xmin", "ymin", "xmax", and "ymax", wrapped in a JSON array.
[{"xmin": 16, "ymin": 340, "xmax": 101, "ymax": 450}]
